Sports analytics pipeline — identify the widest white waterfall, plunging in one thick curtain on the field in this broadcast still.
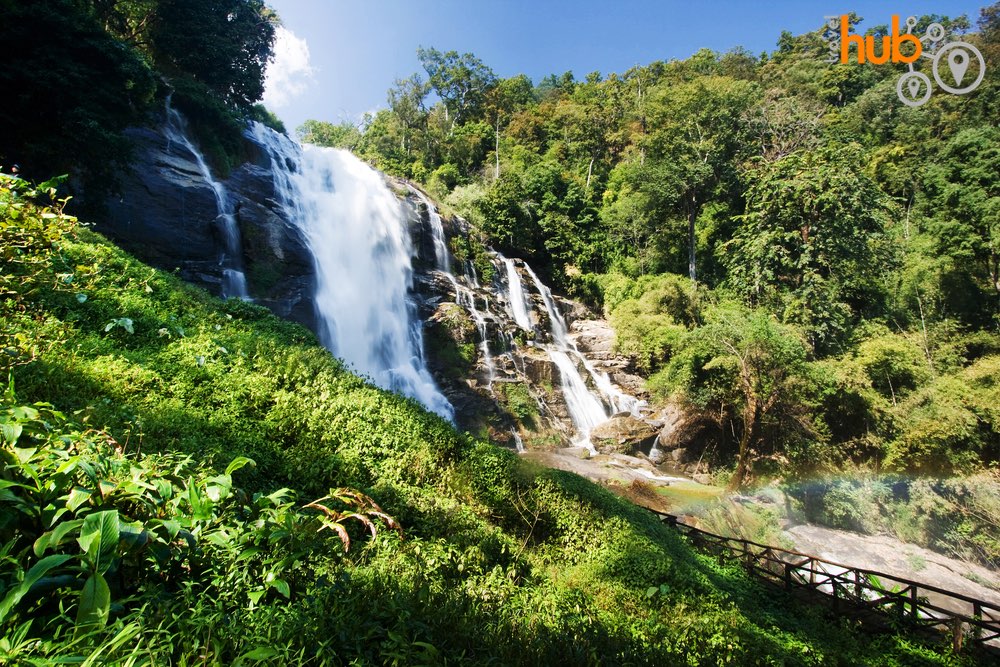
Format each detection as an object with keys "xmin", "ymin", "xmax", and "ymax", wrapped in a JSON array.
[{"xmin": 251, "ymin": 123, "xmax": 454, "ymax": 420}]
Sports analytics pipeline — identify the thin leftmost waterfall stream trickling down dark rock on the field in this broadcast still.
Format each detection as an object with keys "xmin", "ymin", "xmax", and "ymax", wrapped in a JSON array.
[{"xmin": 164, "ymin": 93, "xmax": 249, "ymax": 299}]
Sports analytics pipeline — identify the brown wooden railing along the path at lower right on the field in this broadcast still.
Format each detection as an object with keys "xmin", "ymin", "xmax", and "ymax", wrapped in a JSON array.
[{"xmin": 655, "ymin": 512, "xmax": 1000, "ymax": 651}]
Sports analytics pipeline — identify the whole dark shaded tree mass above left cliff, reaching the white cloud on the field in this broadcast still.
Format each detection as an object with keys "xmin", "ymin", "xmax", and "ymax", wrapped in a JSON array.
[{"xmin": 0, "ymin": 0, "xmax": 277, "ymax": 201}]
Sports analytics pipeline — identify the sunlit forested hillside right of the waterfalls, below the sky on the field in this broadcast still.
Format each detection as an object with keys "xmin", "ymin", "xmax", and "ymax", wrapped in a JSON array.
[{"xmin": 298, "ymin": 3, "xmax": 1000, "ymax": 512}]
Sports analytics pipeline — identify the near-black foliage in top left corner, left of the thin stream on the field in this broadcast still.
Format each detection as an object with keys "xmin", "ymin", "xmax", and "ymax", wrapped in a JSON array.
[{"xmin": 0, "ymin": 0, "xmax": 155, "ymax": 195}]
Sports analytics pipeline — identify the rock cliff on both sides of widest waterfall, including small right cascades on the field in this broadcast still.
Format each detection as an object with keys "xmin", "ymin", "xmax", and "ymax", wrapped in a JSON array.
[{"xmin": 90, "ymin": 115, "xmax": 708, "ymax": 465}]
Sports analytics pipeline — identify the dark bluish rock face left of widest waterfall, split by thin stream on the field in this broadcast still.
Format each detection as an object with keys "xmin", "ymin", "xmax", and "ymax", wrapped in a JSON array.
[{"xmin": 95, "ymin": 121, "xmax": 315, "ymax": 328}]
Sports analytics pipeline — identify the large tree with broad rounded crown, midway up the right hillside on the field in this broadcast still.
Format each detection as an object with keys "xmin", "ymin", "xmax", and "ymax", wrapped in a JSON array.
[{"xmin": 725, "ymin": 145, "xmax": 893, "ymax": 348}]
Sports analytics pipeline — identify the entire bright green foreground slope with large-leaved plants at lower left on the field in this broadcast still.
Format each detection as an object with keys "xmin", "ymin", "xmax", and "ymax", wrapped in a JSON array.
[{"xmin": 0, "ymin": 176, "xmax": 968, "ymax": 665}]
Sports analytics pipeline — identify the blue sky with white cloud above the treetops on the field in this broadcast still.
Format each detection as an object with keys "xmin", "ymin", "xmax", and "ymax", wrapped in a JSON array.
[{"xmin": 265, "ymin": 0, "xmax": 990, "ymax": 129}]
